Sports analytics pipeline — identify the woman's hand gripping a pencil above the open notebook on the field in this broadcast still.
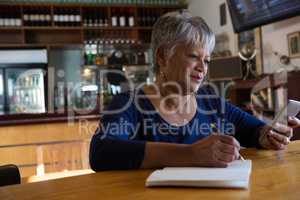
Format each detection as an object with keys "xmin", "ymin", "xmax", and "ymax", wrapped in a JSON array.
[{"xmin": 190, "ymin": 135, "xmax": 240, "ymax": 167}]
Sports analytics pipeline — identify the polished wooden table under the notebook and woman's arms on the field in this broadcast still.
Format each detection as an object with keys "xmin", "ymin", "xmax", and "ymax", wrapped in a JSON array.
[{"xmin": 0, "ymin": 141, "xmax": 300, "ymax": 200}]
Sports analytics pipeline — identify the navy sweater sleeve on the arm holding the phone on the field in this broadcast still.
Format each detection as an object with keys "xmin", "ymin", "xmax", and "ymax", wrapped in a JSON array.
[{"xmin": 223, "ymin": 102, "xmax": 265, "ymax": 148}]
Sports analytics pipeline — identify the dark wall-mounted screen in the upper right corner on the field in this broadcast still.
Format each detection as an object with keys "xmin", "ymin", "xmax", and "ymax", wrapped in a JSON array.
[{"xmin": 227, "ymin": 0, "xmax": 300, "ymax": 32}]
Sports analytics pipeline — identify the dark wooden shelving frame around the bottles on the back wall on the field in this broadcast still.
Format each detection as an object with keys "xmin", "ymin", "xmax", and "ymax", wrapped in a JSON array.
[{"xmin": 0, "ymin": 3, "xmax": 186, "ymax": 47}]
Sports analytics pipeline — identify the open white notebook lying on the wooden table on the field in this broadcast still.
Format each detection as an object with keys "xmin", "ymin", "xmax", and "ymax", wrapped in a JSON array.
[{"xmin": 146, "ymin": 160, "xmax": 251, "ymax": 188}]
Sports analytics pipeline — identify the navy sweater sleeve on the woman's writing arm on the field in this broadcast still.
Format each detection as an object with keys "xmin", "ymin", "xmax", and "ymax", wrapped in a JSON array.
[{"xmin": 90, "ymin": 94, "xmax": 145, "ymax": 171}]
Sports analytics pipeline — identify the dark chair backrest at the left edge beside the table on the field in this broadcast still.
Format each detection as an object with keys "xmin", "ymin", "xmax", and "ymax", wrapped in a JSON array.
[{"xmin": 0, "ymin": 165, "xmax": 21, "ymax": 186}]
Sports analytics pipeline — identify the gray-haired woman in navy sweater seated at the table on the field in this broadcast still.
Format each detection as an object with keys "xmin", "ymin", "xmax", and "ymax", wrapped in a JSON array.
[{"xmin": 90, "ymin": 10, "xmax": 299, "ymax": 171}]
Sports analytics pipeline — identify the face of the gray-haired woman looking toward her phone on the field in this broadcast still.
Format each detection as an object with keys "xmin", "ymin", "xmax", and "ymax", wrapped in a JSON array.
[{"xmin": 160, "ymin": 45, "xmax": 210, "ymax": 94}]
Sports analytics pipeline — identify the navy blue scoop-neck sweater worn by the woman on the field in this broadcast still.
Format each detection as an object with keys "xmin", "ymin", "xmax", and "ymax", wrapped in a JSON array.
[{"xmin": 90, "ymin": 87, "xmax": 264, "ymax": 171}]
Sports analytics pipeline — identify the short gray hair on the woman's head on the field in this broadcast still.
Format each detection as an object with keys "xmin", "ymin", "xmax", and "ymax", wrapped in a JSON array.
[{"xmin": 151, "ymin": 10, "xmax": 215, "ymax": 72}]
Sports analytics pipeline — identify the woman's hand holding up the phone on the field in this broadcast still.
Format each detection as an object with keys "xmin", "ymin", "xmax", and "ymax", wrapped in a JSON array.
[{"xmin": 259, "ymin": 117, "xmax": 300, "ymax": 150}]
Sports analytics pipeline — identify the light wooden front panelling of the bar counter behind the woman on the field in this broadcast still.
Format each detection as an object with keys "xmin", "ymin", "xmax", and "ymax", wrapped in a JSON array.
[{"xmin": 0, "ymin": 120, "xmax": 98, "ymax": 177}]
